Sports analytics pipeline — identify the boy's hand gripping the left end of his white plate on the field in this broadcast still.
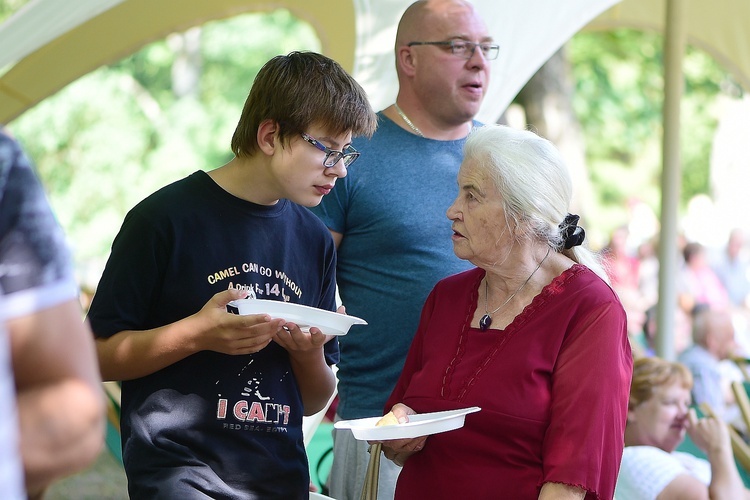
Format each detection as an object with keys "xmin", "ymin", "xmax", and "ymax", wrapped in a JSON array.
[{"xmin": 195, "ymin": 289, "xmax": 285, "ymax": 355}]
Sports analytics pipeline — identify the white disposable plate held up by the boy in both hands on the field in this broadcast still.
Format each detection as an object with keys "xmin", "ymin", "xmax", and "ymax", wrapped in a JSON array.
[{"xmin": 227, "ymin": 299, "xmax": 367, "ymax": 335}]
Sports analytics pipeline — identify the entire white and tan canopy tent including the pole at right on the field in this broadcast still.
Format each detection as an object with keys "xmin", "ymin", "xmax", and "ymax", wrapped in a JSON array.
[{"xmin": 0, "ymin": 0, "xmax": 750, "ymax": 359}]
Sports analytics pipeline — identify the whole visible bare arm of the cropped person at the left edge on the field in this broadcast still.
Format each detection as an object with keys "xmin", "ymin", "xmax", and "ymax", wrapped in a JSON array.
[{"xmin": 6, "ymin": 299, "xmax": 104, "ymax": 493}]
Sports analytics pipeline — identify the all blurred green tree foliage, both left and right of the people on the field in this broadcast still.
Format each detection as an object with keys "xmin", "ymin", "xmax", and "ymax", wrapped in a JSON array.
[{"xmin": 0, "ymin": 0, "xmax": 739, "ymax": 283}]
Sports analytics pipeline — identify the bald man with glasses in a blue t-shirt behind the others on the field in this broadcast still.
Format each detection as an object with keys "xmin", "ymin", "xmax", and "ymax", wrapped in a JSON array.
[{"xmin": 312, "ymin": 0, "xmax": 499, "ymax": 500}]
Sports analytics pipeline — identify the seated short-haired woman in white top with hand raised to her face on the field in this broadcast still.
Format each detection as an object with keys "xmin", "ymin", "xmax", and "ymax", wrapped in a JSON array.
[{"xmin": 617, "ymin": 358, "xmax": 750, "ymax": 500}]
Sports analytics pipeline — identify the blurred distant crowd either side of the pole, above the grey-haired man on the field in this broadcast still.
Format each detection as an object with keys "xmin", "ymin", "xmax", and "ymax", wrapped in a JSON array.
[{"xmin": 601, "ymin": 225, "xmax": 750, "ymax": 357}]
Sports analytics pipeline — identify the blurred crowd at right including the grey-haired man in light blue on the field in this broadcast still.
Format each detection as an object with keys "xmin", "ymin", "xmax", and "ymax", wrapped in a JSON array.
[{"xmin": 602, "ymin": 219, "xmax": 750, "ymax": 431}]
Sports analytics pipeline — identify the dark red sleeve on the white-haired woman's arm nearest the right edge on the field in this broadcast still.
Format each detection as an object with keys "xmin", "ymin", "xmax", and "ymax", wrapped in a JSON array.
[{"xmin": 542, "ymin": 299, "xmax": 632, "ymax": 498}]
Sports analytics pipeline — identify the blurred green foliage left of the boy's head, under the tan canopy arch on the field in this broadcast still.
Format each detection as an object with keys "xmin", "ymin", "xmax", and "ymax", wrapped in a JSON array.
[{"xmin": 0, "ymin": 8, "xmax": 320, "ymax": 284}]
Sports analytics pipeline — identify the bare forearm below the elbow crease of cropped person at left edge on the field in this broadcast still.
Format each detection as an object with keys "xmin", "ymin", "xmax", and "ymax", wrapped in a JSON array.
[{"xmin": 18, "ymin": 378, "xmax": 104, "ymax": 493}]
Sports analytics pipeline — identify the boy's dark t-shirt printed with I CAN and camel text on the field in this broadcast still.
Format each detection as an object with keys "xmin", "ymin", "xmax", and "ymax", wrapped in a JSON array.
[{"xmin": 88, "ymin": 171, "xmax": 338, "ymax": 499}]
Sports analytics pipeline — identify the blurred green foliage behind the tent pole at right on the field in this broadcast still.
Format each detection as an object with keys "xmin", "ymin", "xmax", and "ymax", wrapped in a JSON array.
[{"xmin": 568, "ymin": 30, "xmax": 740, "ymax": 221}]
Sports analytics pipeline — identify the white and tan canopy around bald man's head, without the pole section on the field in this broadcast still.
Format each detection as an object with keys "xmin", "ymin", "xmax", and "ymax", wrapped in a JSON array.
[{"xmin": 0, "ymin": 0, "xmax": 616, "ymax": 123}]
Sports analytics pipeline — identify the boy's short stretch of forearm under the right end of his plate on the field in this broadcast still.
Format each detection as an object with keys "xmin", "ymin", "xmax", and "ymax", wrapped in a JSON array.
[{"xmin": 290, "ymin": 348, "xmax": 336, "ymax": 415}]
